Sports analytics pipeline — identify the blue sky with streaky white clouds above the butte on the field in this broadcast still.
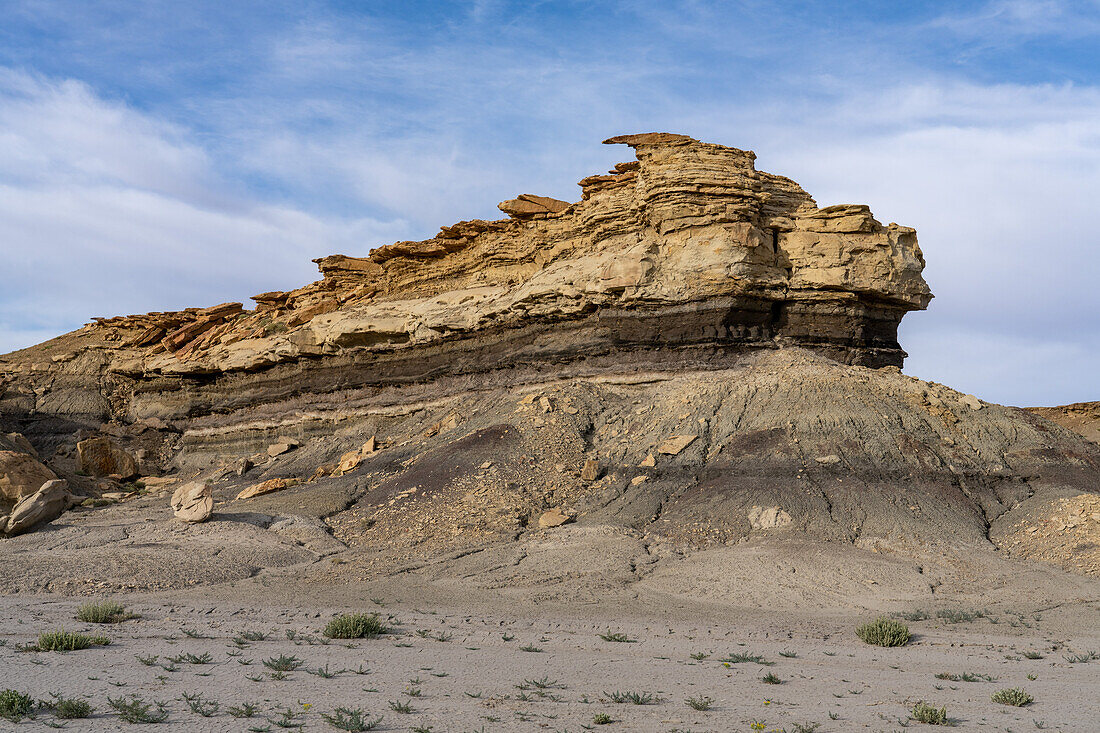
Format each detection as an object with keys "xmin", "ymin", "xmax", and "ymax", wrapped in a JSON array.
[{"xmin": 0, "ymin": 0, "xmax": 1100, "ymax": 404}]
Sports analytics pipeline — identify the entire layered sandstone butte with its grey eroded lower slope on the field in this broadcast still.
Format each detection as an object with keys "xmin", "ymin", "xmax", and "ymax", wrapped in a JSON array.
[{"xmin": 0, "ymin": 133, "xmax": 1100, "ymax": 582}]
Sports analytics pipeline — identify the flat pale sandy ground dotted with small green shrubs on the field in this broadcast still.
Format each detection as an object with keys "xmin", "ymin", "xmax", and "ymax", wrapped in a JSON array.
[{"xmin": 0, "ymin": 580, "xmax": 1100, "ymax": 733}]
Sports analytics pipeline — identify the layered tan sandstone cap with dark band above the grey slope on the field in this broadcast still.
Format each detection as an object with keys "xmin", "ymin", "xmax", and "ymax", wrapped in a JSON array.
[{"xmin": 0, "ymin": 133, "xmax": 932, "ymax": 429}]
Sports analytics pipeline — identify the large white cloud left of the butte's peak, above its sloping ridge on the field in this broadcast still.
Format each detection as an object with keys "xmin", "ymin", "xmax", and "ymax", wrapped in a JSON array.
[{"xmin": 0, "ymin": 70, "xmax": 406, "ymax": 352}]
